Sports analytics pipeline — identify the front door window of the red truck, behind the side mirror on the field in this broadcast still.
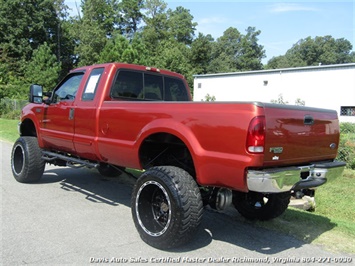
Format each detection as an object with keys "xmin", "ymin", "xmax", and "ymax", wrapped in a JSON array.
[{"xmin": 52, "ymin": 72, "xmax": 84, "ymax": 103}]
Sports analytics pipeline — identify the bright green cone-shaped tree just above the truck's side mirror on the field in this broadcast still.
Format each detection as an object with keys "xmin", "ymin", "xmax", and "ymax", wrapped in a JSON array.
[{"xmin": 25, "ymin": 43, "xmax": 61, "ymax": 90}]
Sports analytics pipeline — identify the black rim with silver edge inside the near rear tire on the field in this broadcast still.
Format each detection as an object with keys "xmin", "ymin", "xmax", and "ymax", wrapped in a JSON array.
[{"xmin": 135, "ymin": 181, "xmax": 172, "ymax": 237}]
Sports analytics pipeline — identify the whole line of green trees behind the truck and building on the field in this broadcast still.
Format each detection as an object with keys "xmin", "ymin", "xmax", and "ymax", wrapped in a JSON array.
[{"xmin": 0, "ymin": 0, "xmax": 355, "ymax": 99}]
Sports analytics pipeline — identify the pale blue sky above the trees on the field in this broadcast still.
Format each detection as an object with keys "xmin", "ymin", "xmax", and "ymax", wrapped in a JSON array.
[{"xmin": 65, "ymin": 0, "xmax": 355, "ymax": 63}]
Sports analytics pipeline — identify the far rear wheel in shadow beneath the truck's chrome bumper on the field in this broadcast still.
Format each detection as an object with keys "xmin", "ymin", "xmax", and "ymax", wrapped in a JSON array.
[{"xmin": 233, "ymin": 191, "xmax": 291, "ymax": 221}]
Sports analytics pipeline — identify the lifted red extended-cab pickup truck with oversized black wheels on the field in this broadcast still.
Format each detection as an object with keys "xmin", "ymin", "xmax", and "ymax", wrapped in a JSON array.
[{"xmin": 11, "ymin": 63, "xmax": 345, "ymax": 249}]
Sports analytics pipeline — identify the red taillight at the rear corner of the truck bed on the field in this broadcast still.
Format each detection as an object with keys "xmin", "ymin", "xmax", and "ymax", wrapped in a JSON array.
[{"xmin": 246, "ymin": 116, "xmax": 266, "ymax": 153}]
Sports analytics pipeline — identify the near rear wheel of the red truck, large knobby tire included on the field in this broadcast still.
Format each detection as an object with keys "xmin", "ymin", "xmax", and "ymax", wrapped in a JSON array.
[{"xmin": 131, "ymin": 166, "xmax": 203, "ymax": 249}]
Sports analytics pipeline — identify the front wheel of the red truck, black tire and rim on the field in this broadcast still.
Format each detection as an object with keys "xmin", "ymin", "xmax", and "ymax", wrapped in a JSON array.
[{"xmin": 11, "ymin": 137, "xmax": 45, "ymax": 183}]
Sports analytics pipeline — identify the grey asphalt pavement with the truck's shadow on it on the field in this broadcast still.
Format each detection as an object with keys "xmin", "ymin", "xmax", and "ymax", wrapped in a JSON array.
[{"xmin": 0, "ymin": 141, "xmax": 355, "ymax": 266}]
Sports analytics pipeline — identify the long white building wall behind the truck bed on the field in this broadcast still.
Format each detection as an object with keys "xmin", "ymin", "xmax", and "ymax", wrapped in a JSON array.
[{"xmin": 194, "ymin": 64, "xmax": 355, "ymax": 123}]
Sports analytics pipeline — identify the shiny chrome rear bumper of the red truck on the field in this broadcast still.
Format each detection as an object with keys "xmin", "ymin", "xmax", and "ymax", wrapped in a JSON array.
[{"xmin": 247, "ymin": 161, "xmax": 346, "ymax": 193}]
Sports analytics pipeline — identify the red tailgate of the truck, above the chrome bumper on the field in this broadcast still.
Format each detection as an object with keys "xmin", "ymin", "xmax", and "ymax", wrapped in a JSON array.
[{"xmin": 264, "ymin": 104, "xmax": 339, "ymax": 166}]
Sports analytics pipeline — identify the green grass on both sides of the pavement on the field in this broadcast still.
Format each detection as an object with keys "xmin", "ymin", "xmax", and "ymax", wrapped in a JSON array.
[{"xmin": 0, "ymin": 119, "xmax": 355, "ymax": 254}]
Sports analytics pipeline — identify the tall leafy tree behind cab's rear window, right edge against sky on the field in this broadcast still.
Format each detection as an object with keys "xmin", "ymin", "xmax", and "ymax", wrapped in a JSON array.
[{"xmin": 139, "ymin": 0, "xmax": 197, "ymax": 74}]
